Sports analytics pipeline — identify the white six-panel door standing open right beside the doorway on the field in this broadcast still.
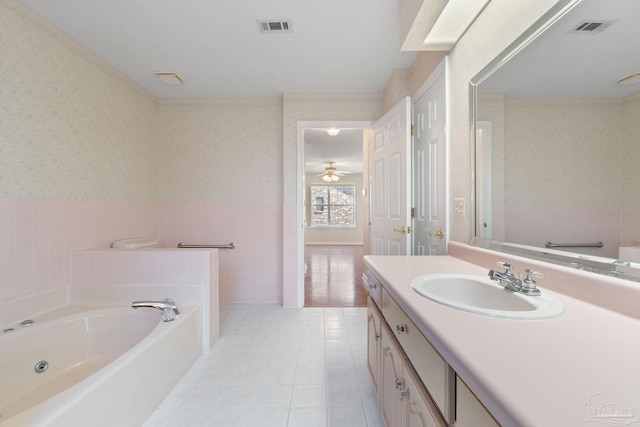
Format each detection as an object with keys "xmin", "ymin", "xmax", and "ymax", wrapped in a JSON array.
[{"xmin": 370, "ymin": 97, "xmax": 411, "ymax": 255}]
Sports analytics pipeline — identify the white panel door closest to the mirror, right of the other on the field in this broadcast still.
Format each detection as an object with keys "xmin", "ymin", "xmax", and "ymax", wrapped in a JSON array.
[{"xmin": 413, "ymin": 63, "xmax": 447, "ymax": 255}]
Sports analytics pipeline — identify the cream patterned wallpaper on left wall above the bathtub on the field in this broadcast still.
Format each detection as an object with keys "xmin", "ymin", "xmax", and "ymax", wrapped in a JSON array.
[{"xmin": 0, "ymin": 0, "xmax": 156, "ymax": 201}]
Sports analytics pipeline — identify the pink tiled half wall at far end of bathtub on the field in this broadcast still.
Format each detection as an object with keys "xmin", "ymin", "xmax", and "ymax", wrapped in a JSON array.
[{"xmin": 70, "ymin": 248, "xmax": 220, "ymax": 352}]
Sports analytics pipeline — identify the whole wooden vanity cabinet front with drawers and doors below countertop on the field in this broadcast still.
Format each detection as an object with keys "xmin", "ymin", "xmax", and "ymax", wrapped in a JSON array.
[{"xmin": 363, "ymin": 273, "xmax": 500, "ymax": 427}]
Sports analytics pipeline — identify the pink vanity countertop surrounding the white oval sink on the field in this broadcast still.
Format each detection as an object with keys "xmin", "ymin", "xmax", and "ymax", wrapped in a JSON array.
[{"xmin": 365, "ymin": 255, "xmax": 640, "ymax": 427}]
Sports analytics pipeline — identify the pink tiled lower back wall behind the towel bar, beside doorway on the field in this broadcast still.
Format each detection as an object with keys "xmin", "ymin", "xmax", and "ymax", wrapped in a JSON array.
[{"xmin": 159, "ymin": 205, "xmax": 283, "ymax": 304}]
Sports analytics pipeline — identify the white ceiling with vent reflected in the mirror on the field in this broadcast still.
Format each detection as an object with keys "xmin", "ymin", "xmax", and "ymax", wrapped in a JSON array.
[{"xmin": 479, "ymin": 0, "xmax": 640, "ymax": 99}]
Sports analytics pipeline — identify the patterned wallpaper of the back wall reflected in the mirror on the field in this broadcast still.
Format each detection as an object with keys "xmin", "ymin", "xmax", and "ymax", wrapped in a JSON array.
[{"xmin": 504, "ymin": 100, "xmax": 624, "ymax": 203}]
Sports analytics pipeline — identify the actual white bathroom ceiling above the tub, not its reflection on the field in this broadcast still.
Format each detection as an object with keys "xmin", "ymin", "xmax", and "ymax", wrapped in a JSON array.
[{"xmin": 22, "ymin": 0, "xmax": 415, "ymax": 98}]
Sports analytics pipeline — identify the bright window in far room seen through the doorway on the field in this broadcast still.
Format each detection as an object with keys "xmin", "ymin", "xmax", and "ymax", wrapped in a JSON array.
[{"xmin": 309, "ymin": 185, "xmax": 356, "ymax": 227}]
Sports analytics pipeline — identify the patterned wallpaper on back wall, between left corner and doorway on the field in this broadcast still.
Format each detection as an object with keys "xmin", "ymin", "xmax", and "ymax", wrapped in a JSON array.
[{"xmin": 156, "ymin": 99, "xmax": 282, "ymax": 205}]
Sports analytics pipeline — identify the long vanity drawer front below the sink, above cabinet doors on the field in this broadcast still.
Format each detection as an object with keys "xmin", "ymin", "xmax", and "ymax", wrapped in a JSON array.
[{"xmin": 382, "ymin": 289, "xmax": 453, "ymax": 421}]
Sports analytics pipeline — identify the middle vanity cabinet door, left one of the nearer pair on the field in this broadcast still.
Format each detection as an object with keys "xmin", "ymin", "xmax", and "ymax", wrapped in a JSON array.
[{"xmin": 380, "ymin": 326, "xmax": 404, "ymax": 427}]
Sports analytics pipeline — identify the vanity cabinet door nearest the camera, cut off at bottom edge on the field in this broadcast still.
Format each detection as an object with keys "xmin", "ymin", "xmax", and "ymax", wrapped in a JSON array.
[{"xmin": 401, "ymin": 366, "xmax": 446, "ymax": 427}]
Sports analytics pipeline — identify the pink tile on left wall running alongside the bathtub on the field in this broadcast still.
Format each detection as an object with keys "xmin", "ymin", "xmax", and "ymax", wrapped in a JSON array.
[{"xmin": 0, "ymin": 198, "xmax": 158, "ymax": 303}]
